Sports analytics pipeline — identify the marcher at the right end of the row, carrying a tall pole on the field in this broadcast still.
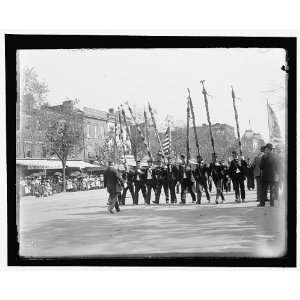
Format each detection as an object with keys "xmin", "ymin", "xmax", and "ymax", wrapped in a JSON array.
[{"xmin": 229, "ymin": 151, "xmax": 247, "ymax": 203}]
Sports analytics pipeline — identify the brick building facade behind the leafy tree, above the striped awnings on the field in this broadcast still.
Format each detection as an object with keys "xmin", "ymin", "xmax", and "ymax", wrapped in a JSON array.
[{"xmin": 16, "ymin": 100, "xmax": 131, "ymax": 163}]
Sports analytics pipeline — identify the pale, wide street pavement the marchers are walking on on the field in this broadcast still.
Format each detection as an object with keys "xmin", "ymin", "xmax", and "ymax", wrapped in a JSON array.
[{"xmin": 19, "ymin": 190, "xmax": 285, "ymax": 257}]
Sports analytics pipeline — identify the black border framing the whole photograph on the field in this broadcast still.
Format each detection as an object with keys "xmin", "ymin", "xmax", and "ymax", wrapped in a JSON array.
[{"xmin": 5, "ymin": 34, "xmax": 297, "ymax": 267}]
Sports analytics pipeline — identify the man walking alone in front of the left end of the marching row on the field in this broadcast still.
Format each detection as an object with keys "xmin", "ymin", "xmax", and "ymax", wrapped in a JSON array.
[{"xmin": 104, "ymin": 161, "xmax": 122, "ymax": 214}]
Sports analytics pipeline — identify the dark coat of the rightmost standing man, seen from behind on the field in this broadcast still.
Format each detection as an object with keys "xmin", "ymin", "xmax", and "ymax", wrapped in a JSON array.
[{"xmin": 260, "ymin": 153, "xmax": 280, "ymax": 182}]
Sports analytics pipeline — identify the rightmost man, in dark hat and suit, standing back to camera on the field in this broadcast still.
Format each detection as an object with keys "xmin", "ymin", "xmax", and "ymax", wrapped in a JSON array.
[{"xmin": 258, "ymin": 143, "xmax": 280, "ymax": 206}]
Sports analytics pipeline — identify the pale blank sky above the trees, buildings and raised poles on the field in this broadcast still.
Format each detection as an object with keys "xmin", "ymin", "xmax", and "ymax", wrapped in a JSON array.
[{"xmin": 20, "ymin": 48, "xmax": 285, "ymax": 141}]
